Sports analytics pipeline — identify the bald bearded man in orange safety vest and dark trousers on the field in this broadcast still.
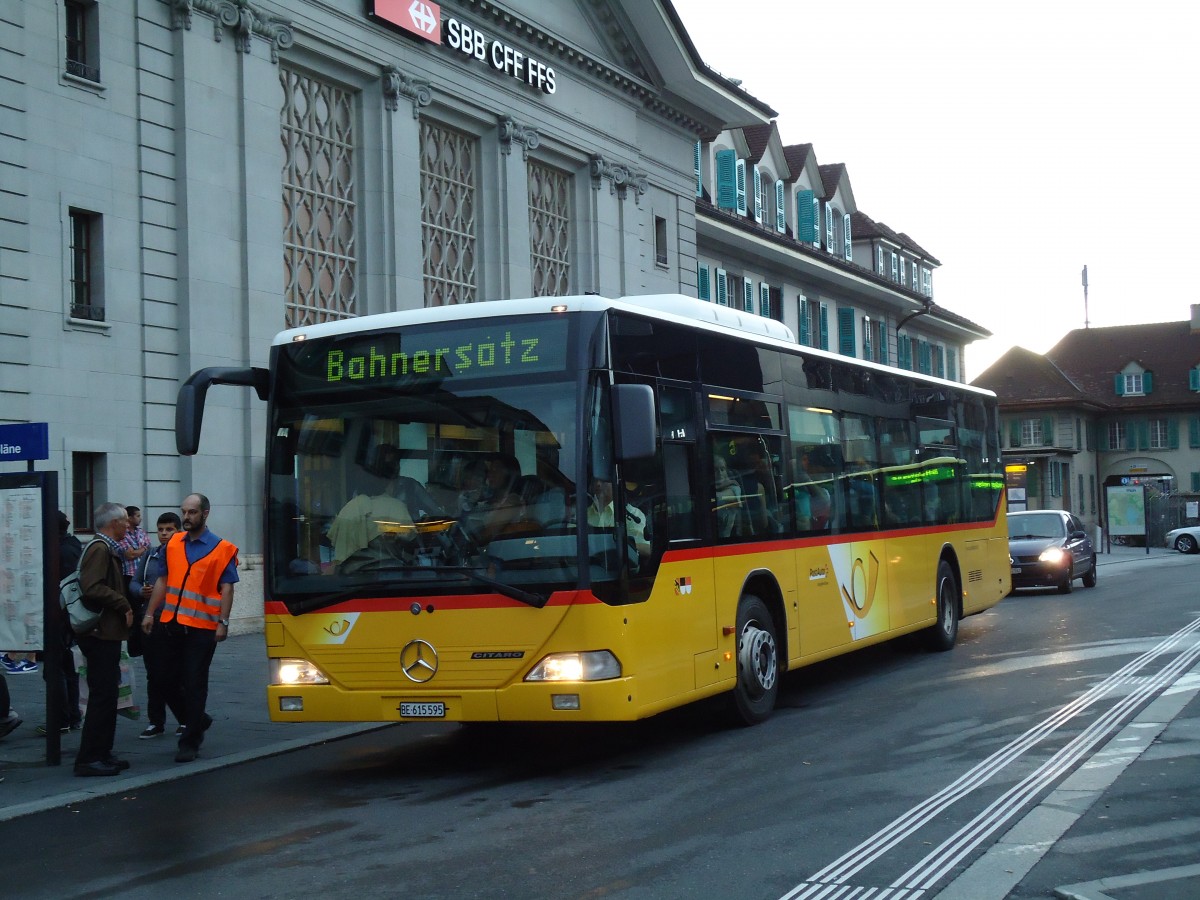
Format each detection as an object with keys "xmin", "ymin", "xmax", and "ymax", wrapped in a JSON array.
[{"xmin": 142, "ymin": 493, "xmax": 238, "ymax": 762}]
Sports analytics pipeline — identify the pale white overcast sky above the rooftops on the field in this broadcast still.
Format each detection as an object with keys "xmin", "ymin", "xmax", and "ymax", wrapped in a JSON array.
[{"xmin": 673, "ymin": 0, "xmax": 1200, "ymax": 379}]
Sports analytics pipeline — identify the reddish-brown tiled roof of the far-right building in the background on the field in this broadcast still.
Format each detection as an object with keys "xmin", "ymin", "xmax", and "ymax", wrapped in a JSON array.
[{"xmin": 972, "ymin": 322, "xmax": 1200, "ymax": 409}]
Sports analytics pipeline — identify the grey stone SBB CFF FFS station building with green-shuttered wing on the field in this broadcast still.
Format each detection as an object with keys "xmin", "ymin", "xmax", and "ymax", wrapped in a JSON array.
[{"xmin": 0, "ymin": 0, "xmax": 988, "ymax": 560}]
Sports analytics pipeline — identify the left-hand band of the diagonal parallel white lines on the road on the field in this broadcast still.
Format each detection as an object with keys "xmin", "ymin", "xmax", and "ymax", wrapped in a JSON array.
[{"xmin": 780, "ymin": 619, "xmax": 1200, "ymax": 900}]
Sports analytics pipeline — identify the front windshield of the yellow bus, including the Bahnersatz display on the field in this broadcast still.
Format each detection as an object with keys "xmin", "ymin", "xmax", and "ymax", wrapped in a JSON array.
[{"xmin": 266, "ymin": 320, "xmax": 592, "ymax": 611}]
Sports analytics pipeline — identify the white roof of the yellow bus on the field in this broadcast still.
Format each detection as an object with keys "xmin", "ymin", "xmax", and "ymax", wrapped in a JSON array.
[{"xmin": 272, "ymin": 294, "xmax": 996, "ymax": 397}]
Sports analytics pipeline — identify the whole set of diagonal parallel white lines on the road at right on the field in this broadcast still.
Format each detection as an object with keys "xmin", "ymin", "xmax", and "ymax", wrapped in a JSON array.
[{"xmin": 780, "ymin": 619, "xmax": 1200, "ymax": 900}]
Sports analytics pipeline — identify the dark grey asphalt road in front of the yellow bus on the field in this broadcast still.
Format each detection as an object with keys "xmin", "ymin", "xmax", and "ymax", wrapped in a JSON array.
[{"xmin": 0, "ymin": 556, "xmax": 1200, "ymax": 900}]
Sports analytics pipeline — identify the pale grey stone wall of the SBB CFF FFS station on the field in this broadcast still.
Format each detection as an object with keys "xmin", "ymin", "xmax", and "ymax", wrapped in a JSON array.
[{"xmin": 0, "ymin": 0, "xmax": 714, "ymax": 554}]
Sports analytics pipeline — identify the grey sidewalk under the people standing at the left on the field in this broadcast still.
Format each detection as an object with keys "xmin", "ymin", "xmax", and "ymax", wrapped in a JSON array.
[{"xmin": 0, "ymin": 634, "xmax": 380, "ymax": 822}]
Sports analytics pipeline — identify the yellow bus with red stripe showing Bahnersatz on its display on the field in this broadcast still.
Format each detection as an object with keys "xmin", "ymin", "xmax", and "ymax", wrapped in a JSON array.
[{"xmin": 176, "ymin": 295, "xmax": 1009, "ymax": 724}]
